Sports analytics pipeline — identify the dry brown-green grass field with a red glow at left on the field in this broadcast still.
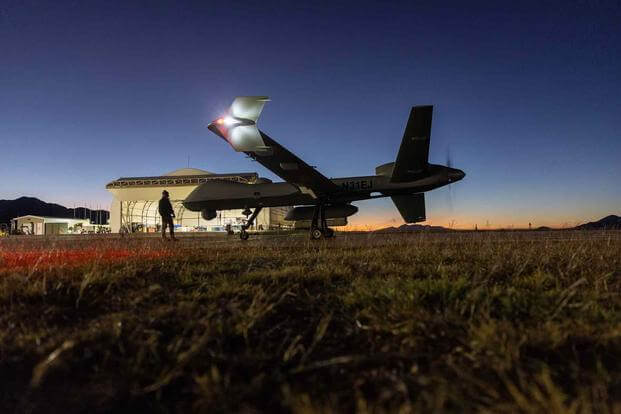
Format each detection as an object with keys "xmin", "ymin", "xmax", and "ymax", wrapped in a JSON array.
[{"xmin": 0, "ymin": 232, "xmax": 621, "ymax": 413}]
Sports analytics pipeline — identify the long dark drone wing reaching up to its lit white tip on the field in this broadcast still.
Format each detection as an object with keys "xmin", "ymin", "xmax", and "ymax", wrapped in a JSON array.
[{"xmin": 208, "ymin": 96, "xmax": 340, "ymax": 196}]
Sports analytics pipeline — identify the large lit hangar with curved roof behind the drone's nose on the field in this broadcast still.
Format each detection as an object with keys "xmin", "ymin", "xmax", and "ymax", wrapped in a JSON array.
[{"xmin": 106, "ymin": 168, "xmax": 292, "ymax": 233}]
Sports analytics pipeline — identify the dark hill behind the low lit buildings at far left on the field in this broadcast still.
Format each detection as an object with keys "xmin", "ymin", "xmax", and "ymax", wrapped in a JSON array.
[{"xmin": 0, "ymin": 197, "xmax": 110, "ymax": 224}]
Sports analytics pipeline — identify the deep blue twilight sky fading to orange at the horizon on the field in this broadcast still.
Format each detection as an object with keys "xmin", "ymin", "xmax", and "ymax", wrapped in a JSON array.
[{"xmin": 0, "ymin": 0, "xmax": 621, "ymax": 228}]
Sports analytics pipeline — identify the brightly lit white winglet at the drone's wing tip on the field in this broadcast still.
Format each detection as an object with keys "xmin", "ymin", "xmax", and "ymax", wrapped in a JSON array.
[{"xmin": 208, "ymin": 96, "xmax": 269, "ymax": 153}]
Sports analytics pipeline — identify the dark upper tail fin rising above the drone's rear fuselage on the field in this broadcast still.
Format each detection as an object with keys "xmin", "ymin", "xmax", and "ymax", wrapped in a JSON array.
[{"xmin": 390, "ymin": 105, "xmax": 433, "ymax": 183}]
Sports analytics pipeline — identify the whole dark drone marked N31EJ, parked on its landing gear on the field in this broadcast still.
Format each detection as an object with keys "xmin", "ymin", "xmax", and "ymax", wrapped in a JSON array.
[{"xmin": 183, "ymin": 96, "xmax": 465, "ymax": 240}]
